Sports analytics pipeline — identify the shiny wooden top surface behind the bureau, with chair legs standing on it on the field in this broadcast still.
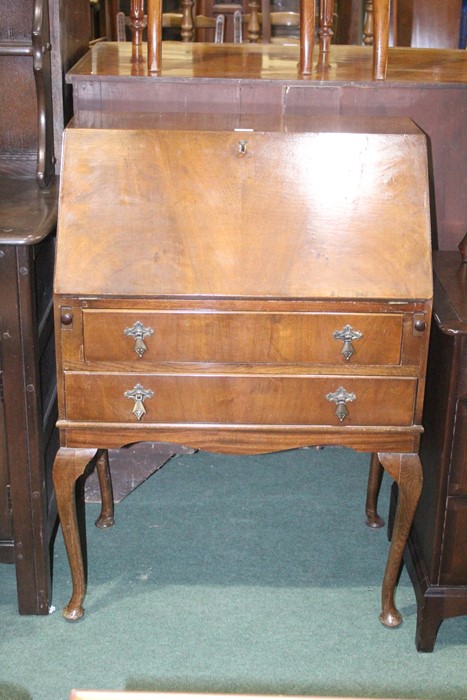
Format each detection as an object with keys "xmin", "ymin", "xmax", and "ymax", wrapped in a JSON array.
[{"xmin": 67, "ymin": 41, "xmax": 467, "ymax": 87}]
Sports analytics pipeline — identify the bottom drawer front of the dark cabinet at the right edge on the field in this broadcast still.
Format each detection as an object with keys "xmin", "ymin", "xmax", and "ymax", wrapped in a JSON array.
[{"xmin": 440, "ymin": 498, "xmax": 467, "ymax": 586}]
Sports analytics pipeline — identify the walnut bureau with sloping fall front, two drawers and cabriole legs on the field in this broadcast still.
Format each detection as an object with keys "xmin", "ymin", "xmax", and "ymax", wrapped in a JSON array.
[{"xmin": 54, "ymin": 114, "xmax": 432, "ymax": 626}]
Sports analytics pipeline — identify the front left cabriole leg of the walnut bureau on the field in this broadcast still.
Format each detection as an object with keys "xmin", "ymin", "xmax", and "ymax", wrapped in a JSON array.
[{"xmin": 53, "ymin": 447, "xmax": 101, "ymax": 620}]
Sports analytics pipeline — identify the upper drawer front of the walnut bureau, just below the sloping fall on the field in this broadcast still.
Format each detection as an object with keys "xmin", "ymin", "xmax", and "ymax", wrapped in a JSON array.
[{"xmin": 83, "ymin": 310, "xmax": 403, "ymax": 365}]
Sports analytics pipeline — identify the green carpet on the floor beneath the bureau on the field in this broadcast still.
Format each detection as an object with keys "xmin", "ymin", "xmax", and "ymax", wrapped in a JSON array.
[{"xmin": 0, "ymin": 448, "xmax": 467, "ymax": 700}]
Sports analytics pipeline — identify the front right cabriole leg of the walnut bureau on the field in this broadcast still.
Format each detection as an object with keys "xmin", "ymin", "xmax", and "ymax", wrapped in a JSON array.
[{"xmin": 378, "ymin": 453, "xmax": 423, "ymax": 627}]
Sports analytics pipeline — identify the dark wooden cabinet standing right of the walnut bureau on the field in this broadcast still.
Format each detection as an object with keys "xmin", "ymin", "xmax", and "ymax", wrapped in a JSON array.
[{"xmin": 393, "ymin": 251, "xmax": 467, "ymax": 651}]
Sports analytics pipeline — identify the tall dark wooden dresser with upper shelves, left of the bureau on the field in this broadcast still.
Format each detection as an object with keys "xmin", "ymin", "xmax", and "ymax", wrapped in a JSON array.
[{"xmin": 0, "ymin": 0, "xmax": 89, "ymax": 614}]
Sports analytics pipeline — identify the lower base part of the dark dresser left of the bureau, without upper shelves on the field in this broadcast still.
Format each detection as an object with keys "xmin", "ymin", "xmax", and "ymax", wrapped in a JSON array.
[{"xmin": 0, "ymin": 182, "xmax": 58, "ymax": 614}]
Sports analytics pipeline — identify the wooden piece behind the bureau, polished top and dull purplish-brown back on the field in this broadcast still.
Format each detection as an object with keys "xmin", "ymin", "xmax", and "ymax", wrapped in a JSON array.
[{"xmin": 68, "ymin": 42, "xmax": 467, "ymax": 250}]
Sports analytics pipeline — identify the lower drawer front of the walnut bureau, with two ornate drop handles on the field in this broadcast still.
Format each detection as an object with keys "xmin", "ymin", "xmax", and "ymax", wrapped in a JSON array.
[{"xmin": 65, "ymin": 372, "xmax": 417, "ymax": 427}]
